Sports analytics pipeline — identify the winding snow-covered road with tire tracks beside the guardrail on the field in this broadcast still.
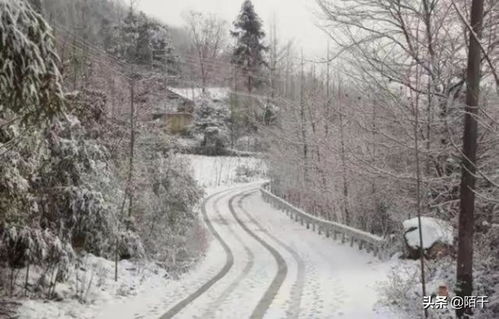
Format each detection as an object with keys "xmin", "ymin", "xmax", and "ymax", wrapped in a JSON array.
[{"xmin": 161, "ymin": 184, "xmax": 396, "ymax": 319}]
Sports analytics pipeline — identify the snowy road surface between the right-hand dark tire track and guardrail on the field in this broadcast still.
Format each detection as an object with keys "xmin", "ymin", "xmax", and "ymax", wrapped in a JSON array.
[{"xmin": 235, "ymin": 192, "xmax": 397, "ymax": 319}]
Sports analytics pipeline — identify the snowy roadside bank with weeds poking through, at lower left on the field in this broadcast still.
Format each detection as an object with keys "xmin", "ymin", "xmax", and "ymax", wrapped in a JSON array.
[{"xmin": 18, "ymin": 254, "xmax": 169, "ymax": 319}]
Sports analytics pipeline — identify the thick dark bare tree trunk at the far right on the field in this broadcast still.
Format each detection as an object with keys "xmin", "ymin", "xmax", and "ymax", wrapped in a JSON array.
[{"xmin": 456, "ymin": 0, "xmax": 483, "ymax": 318}]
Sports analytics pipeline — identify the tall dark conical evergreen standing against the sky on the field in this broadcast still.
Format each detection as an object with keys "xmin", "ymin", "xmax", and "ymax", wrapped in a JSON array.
[{"xmin": 231, "ymin": 0, "xmax": 267, "ymax": 93}]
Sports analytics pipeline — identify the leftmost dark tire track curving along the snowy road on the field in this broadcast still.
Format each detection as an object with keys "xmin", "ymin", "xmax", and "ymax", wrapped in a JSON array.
[{"xmin": 160, "ymin": 189, "xmax": 238, "ymax": 319}]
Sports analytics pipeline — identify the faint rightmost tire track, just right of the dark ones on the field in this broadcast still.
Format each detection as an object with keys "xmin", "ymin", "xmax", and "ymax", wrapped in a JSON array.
[{"xmin": 237, "ymin": 191, "xmax": 305, "ymax": 318}]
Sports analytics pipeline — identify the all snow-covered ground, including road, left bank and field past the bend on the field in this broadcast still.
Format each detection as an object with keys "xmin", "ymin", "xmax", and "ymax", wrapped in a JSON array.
[{"xmin": 19, "ymin": 156, "xmax": 401, "ymax": 319}]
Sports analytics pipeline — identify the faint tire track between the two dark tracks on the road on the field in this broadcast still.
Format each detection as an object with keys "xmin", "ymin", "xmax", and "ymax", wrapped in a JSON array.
[{"xmin": 201, "ymin": 194, "xmax": 255, "ymax": 318}]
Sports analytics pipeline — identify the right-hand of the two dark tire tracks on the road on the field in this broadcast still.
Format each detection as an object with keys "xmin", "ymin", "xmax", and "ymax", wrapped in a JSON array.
[{"xmin": 229, "ymin": 191, "xmax": 288, "ymax": 318}]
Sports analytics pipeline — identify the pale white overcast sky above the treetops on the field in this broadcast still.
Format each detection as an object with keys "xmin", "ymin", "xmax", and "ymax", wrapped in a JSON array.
[{"xmin": 138, "ymin": 0, "xmax": 327, "ymax": 58}]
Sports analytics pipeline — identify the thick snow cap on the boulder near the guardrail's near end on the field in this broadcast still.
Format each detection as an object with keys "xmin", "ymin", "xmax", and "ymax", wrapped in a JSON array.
[{"xmin": 403, "ymin": 216, "xmax": 454, "ymax": 249}]
